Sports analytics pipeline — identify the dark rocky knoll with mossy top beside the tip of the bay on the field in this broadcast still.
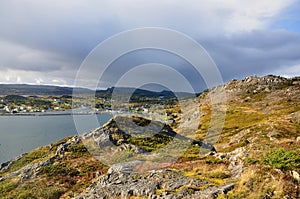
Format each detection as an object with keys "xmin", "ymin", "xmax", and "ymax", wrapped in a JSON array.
[{"xmin": 81, "ymin": 116, "xmax": 216, "ymax": 154}]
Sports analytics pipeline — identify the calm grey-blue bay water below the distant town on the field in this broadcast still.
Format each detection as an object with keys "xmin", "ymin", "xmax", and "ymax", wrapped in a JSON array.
[{"xmin": 0, "ymin": 113, "xmax": 112, "ymax": 163}]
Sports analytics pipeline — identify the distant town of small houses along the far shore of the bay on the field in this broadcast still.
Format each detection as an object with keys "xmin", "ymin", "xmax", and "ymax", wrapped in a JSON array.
[{"xmin": 0, "ymin": 95, "xmax": 176, "ymax": 123}]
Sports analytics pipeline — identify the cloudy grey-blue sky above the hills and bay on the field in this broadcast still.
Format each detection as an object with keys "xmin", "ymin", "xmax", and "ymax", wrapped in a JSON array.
[{"xmin": 0, "ymin": 0, "xmax": 300, "ymax": 91}]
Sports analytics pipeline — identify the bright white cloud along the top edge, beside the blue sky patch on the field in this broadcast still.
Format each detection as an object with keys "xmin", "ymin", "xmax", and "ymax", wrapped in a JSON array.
[{"xmin": 99, "ymin": 0, "xmax": 295, "ymax": 34}]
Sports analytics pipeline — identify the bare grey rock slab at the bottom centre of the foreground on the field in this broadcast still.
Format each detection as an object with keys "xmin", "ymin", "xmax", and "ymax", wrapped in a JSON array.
[{"xmin": 75, "ymin": 161, "xmax": 234, "ymax": 199}]
